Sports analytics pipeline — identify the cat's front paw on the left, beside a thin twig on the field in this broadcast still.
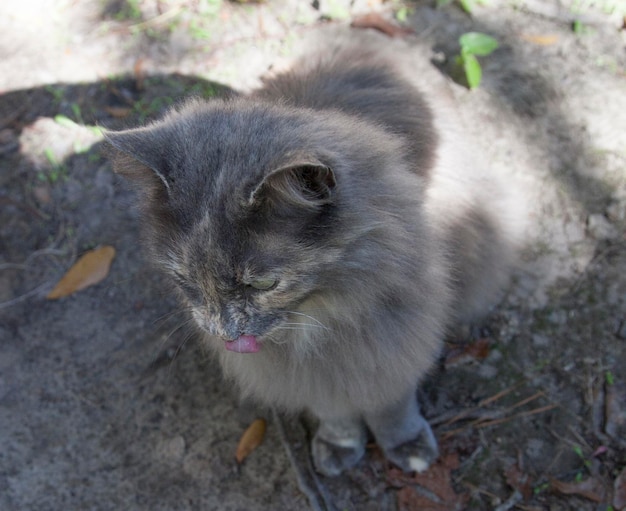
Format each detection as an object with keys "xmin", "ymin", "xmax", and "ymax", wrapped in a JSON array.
[{"xmin": 311, "ymin": 417, "xmax": 367, "ymax": 476}]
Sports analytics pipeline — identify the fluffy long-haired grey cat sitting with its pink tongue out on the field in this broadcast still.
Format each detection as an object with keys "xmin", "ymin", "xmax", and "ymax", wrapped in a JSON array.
[{"xmin": 107, "ymin": 35, "xmax": 511, "ymax": 475}]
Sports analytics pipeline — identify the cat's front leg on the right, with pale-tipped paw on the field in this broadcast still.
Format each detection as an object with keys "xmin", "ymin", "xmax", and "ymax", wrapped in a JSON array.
[{"xmin": 365, "ymin": 391, "xmax": 439, "ymax": 472}]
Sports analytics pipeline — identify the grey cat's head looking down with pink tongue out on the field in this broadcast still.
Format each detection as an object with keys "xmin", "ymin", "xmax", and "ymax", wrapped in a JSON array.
[{"xmin": 107, "ymin": 96, "xmax": 416, "ymax": 352}]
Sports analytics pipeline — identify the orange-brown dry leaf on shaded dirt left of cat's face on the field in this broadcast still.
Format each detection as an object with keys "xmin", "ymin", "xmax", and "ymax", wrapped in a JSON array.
[{"xmin": 46, "ymin": 246, "xmax": 115, "ymax": 300}]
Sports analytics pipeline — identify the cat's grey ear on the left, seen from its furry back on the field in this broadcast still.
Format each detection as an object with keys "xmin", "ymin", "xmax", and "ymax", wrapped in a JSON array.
[{"xmin": 105, "ymin": 128, "xmax": 170, "ymax": 193}]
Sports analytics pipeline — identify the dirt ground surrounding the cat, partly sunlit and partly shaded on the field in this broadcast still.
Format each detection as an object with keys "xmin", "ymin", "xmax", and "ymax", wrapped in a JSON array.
[{"xmin": 0, "ymin": 0, "xmax": 626, "ymax": 511}]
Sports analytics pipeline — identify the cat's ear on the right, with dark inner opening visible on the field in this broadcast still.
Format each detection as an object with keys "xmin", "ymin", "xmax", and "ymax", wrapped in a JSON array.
[{"xmin": 249, "ymin": 156, "xmax": 337, "ymax": 209}]
